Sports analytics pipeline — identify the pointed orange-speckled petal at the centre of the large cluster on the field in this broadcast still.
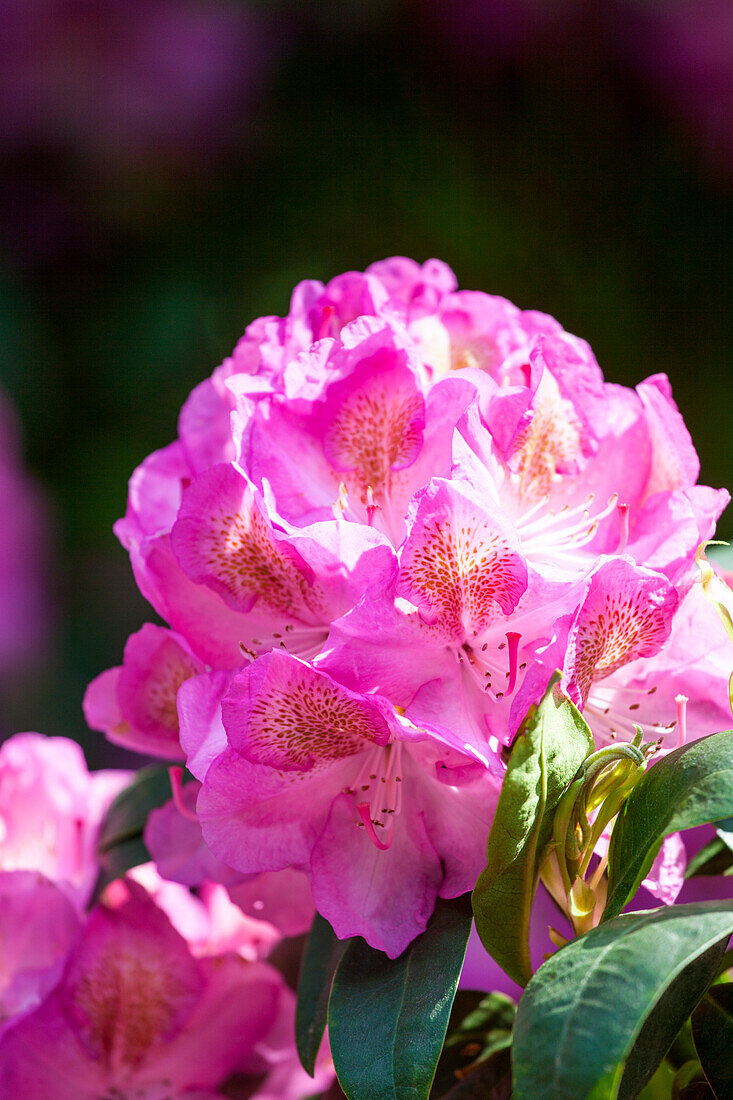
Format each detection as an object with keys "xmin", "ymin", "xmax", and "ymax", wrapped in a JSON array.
[{"xmin": 400, "ymin": 477, "xmax": 527, "ymax": 641}]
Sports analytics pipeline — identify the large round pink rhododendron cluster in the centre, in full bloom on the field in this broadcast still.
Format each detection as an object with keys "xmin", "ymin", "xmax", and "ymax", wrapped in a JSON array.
[{"xmin": 77, "ymin": 259, "xmax": 730, "ymax": 957}]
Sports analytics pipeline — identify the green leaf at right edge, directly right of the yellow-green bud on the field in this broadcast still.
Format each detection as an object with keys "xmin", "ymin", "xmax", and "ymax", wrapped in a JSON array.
[{"xmin": 603, "ymin": 729, "xmax": 733, "ymax": 921}]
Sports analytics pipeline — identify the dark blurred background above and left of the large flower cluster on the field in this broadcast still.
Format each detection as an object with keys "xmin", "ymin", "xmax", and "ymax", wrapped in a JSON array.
[{"xmin": 0, "ymin": 0, "xmax": 733, "ymax": 766}]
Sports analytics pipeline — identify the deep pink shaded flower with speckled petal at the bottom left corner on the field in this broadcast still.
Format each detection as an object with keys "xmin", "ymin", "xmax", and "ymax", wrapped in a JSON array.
[{"xmin": 0, "ymin": 883, "xmax": 331, "ymax": 1100}]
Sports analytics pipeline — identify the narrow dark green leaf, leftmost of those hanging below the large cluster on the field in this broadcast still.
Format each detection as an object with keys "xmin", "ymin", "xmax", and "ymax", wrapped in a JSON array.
[{"xmin": 295, "ymin": 913, "xmax": 350, "ymax": 1077}]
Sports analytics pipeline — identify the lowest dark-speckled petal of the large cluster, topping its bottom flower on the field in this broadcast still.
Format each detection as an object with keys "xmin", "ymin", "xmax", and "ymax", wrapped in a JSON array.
[{"xmin": 221, "ymin": 651, "xmax": 390, "ymax": 771}]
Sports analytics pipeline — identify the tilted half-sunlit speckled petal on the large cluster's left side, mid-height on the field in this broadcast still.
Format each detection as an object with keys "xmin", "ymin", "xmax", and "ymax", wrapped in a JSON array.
[{"xmin": 172, "ymin": 465, "xmax": 311, "ymax": 615}]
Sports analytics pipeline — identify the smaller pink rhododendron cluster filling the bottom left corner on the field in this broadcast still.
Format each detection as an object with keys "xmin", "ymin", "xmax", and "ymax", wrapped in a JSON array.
[{"xmin": 0, "ymin": 734, "xmax": 332, "ymax": 1100}]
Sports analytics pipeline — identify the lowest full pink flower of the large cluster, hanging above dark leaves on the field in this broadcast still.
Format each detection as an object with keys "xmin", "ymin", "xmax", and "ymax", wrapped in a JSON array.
[{"xmin": 189, "ymin": 652, "xmax": 496, "ymax": 956}]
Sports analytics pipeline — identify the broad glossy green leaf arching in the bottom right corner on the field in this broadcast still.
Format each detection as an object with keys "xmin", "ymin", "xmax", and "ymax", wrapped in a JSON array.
[{"xmin": 513, "ymin": 902, "xmax": 733, "ymax": 1100}]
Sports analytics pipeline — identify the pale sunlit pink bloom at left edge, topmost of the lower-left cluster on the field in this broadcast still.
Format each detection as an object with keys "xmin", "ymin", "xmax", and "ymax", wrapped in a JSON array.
[{"xmin": 0, "ymin": 734, "xmax": 130, "ymax": 908}]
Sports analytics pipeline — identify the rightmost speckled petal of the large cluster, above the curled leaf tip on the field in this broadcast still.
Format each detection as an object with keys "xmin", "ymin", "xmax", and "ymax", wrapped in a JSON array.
[{"xmin": 566, "ymin": 558, "xmax": 678, "ymax": 705}]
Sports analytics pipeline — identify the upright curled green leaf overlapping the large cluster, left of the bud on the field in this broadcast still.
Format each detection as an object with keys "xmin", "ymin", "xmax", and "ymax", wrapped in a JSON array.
[{"xmin": 473, "ymin": 673, "xmax": 593, "ymax": 986}]
